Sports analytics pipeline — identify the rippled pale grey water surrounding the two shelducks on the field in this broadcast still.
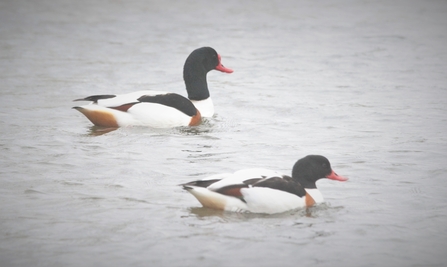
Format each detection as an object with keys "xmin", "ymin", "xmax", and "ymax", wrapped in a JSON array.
[{"xmin": 0, "ymin": 0, "xmax": 447, "ymax": 267}]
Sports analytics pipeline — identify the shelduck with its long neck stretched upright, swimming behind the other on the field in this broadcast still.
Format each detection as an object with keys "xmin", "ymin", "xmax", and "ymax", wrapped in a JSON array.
[{"xmin": 73, "ymin": 47, "xmax": 233, "ymax": 128}]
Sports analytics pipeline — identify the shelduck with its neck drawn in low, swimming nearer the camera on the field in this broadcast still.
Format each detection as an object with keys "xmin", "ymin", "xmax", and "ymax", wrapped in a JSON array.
[{"xmin": 181, "ymin": 155, "xmax": 348, "ymax": 214}]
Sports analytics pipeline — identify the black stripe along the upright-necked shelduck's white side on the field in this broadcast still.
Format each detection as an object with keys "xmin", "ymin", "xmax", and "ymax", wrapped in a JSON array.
[{"xmin": 138, "ymin": 93, "xmax": 197, "ymax": 117}]
